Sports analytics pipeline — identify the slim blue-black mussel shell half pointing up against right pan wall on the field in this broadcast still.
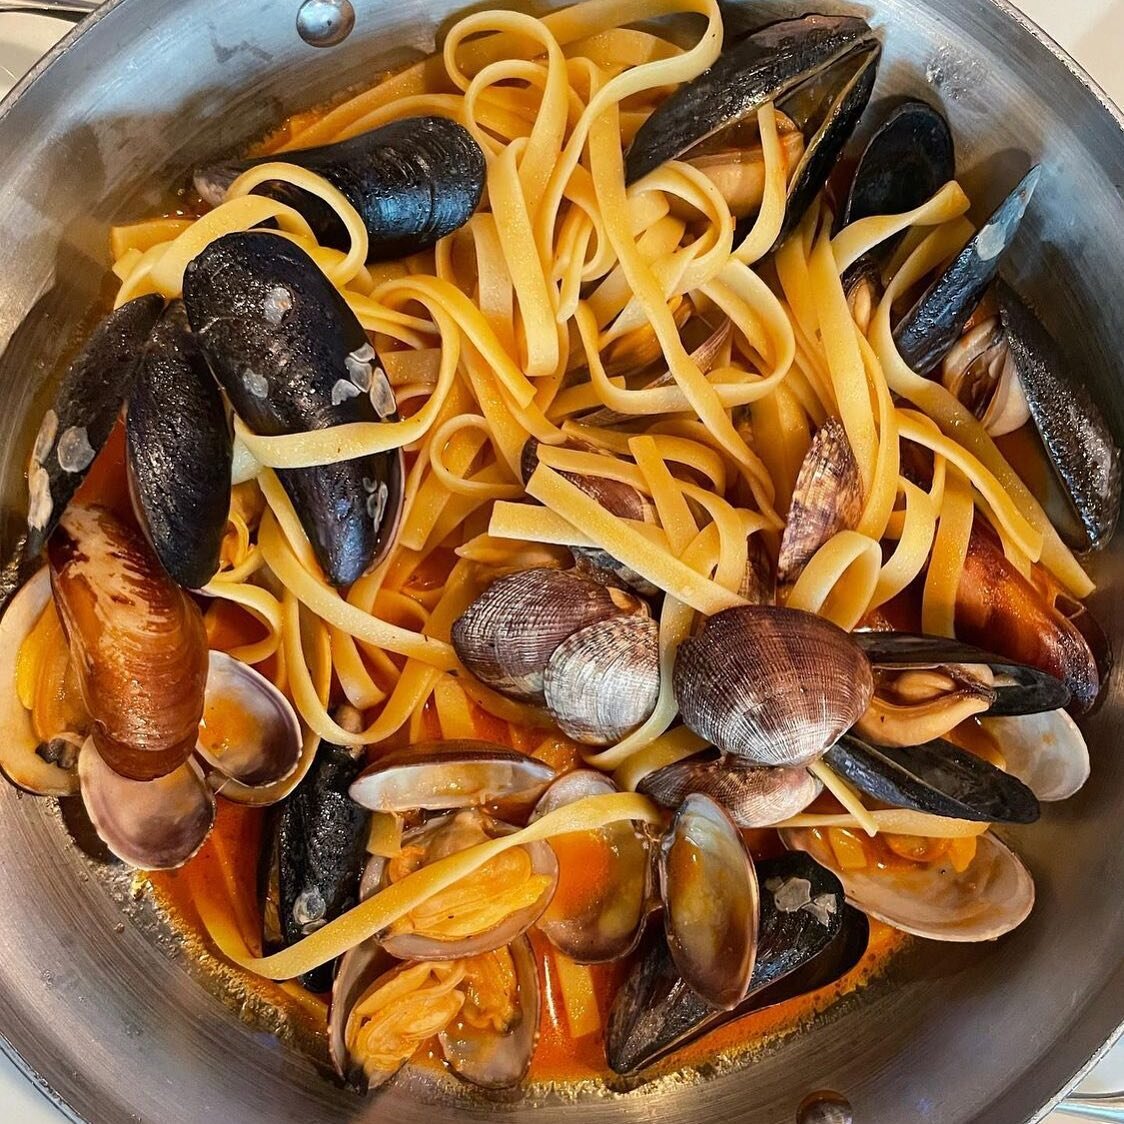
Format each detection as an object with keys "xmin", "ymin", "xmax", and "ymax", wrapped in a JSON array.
[{"xmin": 894, "ymin": 166, "xmax": 1041, "ymax": 374}]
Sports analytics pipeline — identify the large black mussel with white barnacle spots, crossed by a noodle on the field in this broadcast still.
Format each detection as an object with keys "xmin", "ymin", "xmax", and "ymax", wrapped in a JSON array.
[{"xmin": 183, "ymin": 230, "xmax": 402, "ymax": 586}]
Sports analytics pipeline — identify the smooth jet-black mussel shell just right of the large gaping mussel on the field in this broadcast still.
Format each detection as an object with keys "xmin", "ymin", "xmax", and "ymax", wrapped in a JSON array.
[{"xmin": 840, "ymin": 100, "xmax": 957, "ymax": 226}]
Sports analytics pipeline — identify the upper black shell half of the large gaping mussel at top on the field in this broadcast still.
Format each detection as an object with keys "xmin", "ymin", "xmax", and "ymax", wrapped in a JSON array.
[{"xmin": 625, "ymin": 16, "xmax": 871, "ymax": 183}]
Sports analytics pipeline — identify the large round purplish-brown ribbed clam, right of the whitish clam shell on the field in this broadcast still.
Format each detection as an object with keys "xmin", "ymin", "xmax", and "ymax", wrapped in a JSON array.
[{"xmin": 674, "ymin": 605, "xmax": 873, "ymax": 767}]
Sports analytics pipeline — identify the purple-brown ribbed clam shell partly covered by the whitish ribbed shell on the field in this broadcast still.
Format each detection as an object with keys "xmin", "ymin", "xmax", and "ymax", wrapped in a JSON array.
[{"xmin": 452, "ymin": 568, "xmax": 642, "ymax": 704}]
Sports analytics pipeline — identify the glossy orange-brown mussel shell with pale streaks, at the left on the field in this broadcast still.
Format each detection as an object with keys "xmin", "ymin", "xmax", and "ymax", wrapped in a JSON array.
[{"xmin": 47, "ymin": 505, "xmax": 208, "ymax": 780}]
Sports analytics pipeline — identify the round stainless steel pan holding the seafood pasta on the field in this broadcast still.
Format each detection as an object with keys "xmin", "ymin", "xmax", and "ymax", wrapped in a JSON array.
[{"xmin": 0, "ymin": 0, "xmax": 1124, "ymax": 1124}]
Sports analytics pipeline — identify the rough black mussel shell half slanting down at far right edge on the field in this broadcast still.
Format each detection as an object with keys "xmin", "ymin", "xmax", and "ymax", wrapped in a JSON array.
[{"xmin": 996, "ymin": 281, "xmax": 1121, "ymax": 550}]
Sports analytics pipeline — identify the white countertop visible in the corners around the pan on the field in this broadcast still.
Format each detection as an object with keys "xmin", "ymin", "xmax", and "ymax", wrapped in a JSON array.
[{"xmin": 0, "ymin": 0, "xmax": 1124, "ymax": 1124}]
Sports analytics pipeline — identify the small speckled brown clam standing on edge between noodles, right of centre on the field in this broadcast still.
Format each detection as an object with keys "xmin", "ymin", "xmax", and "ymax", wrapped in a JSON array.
[{"xmin": 777, "ymin": 417, "xmax": 862, "ymax": 583}]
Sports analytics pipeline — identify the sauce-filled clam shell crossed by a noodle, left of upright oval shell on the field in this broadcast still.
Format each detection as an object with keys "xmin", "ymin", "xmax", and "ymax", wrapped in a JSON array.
[{"xmin": 532, "ymin": 769, "xmax": 653, "ymax": 964}]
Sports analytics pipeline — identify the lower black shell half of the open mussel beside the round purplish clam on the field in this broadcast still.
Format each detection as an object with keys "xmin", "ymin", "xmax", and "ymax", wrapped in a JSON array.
[{"xmin": 824, "ymin": 734, "xmax": 1040, "ymax": 824}]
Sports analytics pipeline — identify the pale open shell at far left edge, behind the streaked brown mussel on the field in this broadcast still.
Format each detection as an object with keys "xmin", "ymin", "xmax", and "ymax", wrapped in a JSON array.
[{"xmin": 0, "ymin": 566, "xmax": 78, "ymax": 796}]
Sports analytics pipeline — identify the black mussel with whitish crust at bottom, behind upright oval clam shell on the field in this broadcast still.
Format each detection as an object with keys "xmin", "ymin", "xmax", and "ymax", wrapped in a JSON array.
[{"xmin": 606, "ymin": 852, "xmax": 845, "ymax": 1075}]
